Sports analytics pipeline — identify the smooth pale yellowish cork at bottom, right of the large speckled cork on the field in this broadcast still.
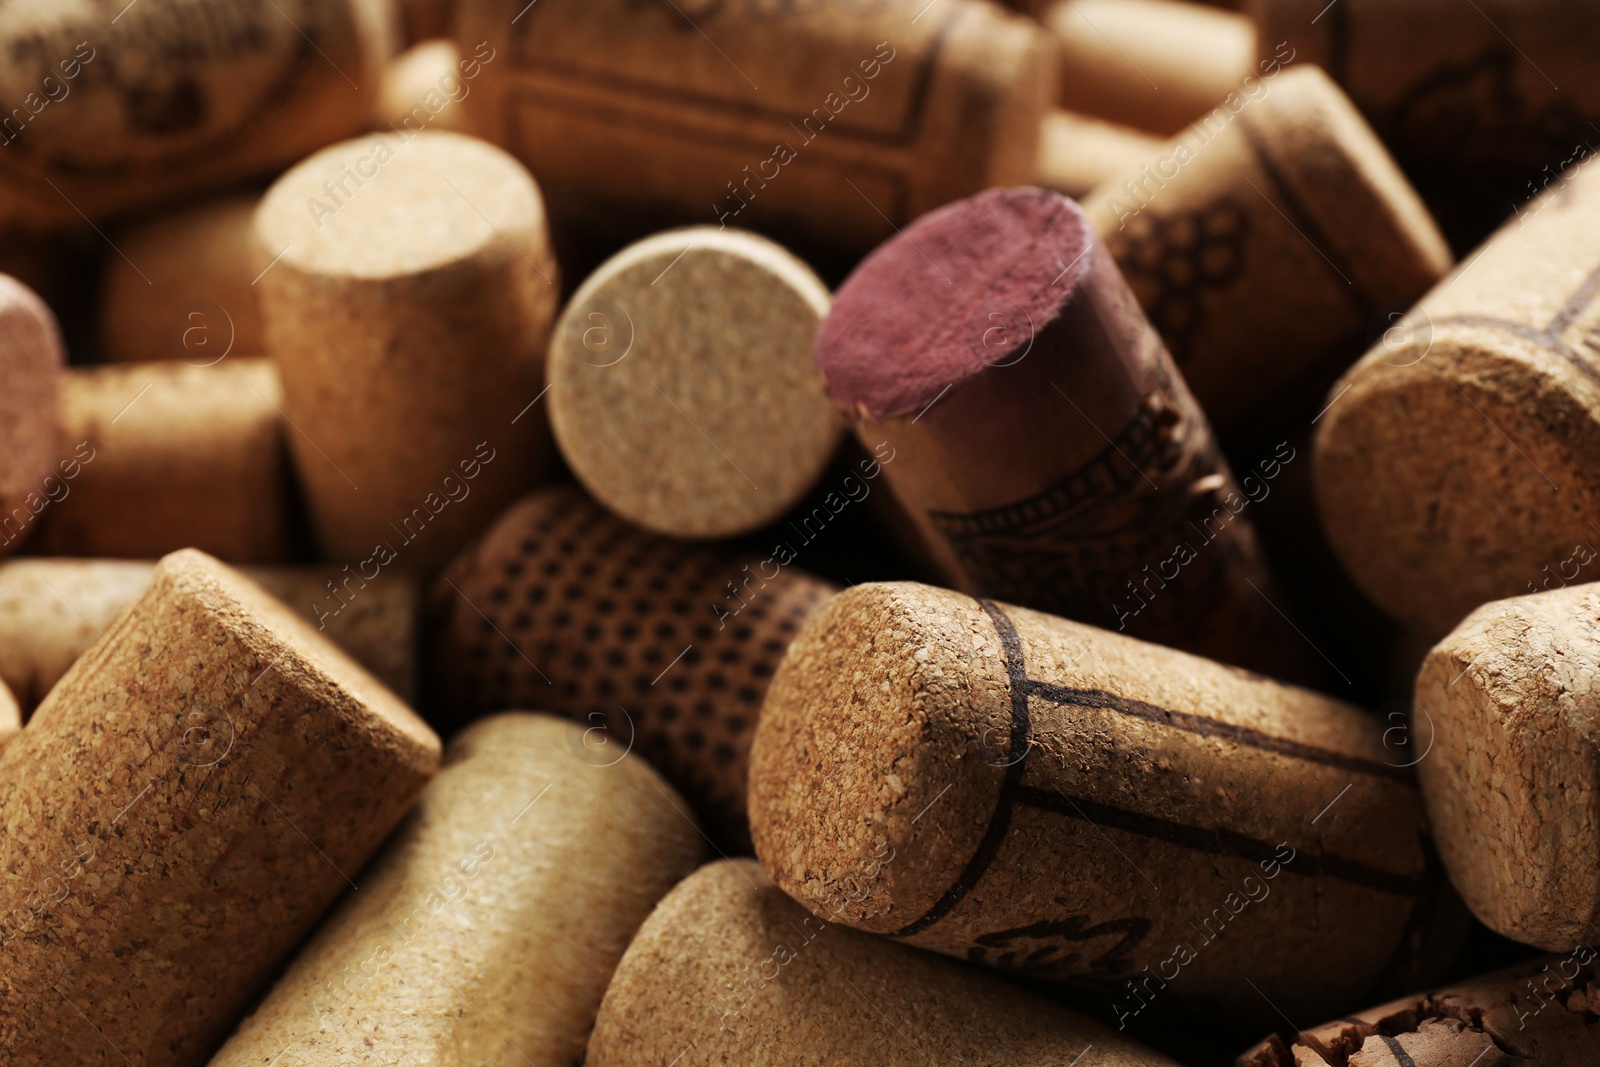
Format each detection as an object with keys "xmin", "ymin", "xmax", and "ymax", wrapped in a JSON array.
[{"xmin": 211, "ymin": 713, "xmax": 706, "ymax": 1067}]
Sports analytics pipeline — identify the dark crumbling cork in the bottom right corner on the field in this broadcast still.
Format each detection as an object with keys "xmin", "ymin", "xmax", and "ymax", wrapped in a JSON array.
[{"xmin": 1237, "ymin": 944, "xmax": 1600, "ymax": 1067}]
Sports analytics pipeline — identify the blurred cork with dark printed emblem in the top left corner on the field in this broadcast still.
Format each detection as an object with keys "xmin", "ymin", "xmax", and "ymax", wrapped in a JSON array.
[{"xmin": 0, "ymin": 0, "xmax": 395, "ymax": 225}]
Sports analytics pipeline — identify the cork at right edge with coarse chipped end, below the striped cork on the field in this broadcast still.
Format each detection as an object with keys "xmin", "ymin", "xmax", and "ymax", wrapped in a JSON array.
[{"xmin": 1411, "ymin": 584, "xmax": 1600, "ymax": 952}]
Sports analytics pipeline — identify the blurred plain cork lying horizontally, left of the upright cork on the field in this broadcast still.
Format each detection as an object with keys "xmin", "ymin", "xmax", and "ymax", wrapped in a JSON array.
[{"xmin": 37, "ymin": 358, "xmax": 299, "ymax": 563}]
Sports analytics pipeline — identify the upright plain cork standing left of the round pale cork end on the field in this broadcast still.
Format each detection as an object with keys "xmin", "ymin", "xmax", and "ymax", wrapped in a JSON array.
[{"xmin": 256, "ymin": 131, "xmax": 557, "ymax": 574}]
